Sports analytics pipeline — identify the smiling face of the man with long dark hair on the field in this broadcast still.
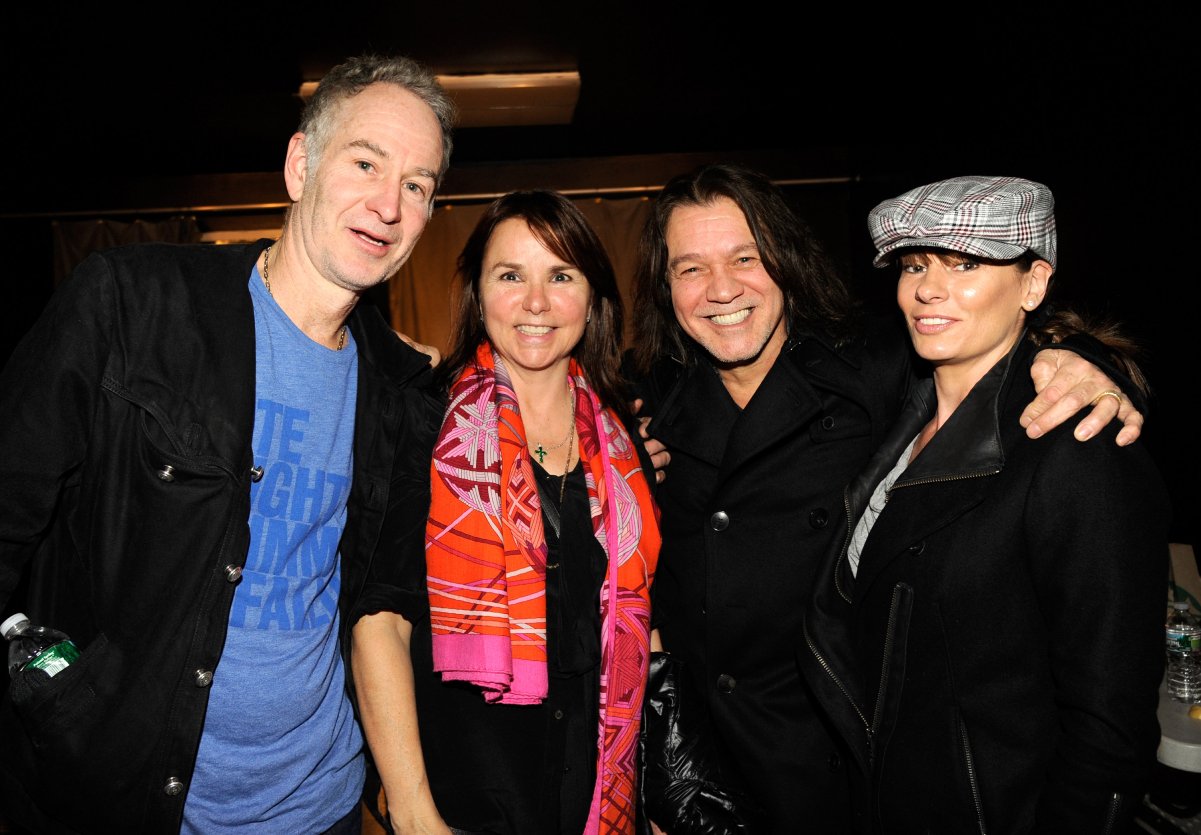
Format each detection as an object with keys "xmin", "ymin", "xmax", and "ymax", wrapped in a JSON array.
[{"xmin": 665, "ymin": 197, "xmax": 787, "ymax": 380}]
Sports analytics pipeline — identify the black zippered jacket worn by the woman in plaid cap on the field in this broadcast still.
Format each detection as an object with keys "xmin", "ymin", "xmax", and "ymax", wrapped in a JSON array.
[{"xmin": 800, "ymin": 340, "xmax": 1167, "ymax": 835}]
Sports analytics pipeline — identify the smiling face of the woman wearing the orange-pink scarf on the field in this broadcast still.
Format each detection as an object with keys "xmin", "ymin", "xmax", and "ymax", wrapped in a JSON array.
[{"xmin": 479, "ymin": 217, "xmax": 592, "ymax": 377}]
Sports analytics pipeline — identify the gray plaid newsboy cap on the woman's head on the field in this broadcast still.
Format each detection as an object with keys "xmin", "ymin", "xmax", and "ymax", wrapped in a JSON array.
[{"xmin": 867, "ymin": 177, "xmax": 1056, "ymax": 268}]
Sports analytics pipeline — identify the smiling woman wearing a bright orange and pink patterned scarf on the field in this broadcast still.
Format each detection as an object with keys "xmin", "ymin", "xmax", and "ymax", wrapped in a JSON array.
[{"xmin": 353, "ymin": 191, "xmax": 659, "ymax": 835}]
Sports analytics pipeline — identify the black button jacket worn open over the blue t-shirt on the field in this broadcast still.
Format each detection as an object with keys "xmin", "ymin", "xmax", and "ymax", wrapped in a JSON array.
[{"xmin": 0, "ymin": 241, "xmax": 437, "ymax": 833}]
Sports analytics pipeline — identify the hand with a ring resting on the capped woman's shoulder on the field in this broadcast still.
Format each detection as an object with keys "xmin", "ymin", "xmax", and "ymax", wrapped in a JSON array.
[{"xmin": 1020, "ymin": 348, "xmax": 1143, "ymax": 447}]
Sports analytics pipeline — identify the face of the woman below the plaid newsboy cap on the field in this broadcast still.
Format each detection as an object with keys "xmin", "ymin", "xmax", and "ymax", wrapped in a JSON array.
[{"xmin": 897, "ymin": 252, "xmax": 1051, "ymax": 381}]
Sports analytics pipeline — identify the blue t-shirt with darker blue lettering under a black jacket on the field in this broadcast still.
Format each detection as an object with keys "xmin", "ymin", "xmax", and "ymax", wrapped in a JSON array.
[{"xmin": 183, "ymin": 269, "xmax": 364, "ymax": 835}]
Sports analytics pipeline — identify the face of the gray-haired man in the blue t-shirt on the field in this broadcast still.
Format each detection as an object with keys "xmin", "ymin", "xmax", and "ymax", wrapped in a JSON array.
[{"xmin": 285, "ymin": 83, "xmax": 442, "ymax": 293}]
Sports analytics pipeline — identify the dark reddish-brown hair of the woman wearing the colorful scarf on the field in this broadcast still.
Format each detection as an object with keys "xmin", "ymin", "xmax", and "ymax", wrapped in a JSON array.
[{"xmin": 437, "ymin": 189, "xmax": 629, "ymax": 416}]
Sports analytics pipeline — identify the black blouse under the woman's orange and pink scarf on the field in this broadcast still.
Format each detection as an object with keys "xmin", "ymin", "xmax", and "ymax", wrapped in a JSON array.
[{"xmin": 412, "ymin": 464, "xmax": 605, "ymax": 835}]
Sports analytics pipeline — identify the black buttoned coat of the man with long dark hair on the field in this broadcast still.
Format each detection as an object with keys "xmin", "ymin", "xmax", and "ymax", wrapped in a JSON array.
[{"xmin": 639, "ymin": 321, "xmax": 912, "ymax": 833}]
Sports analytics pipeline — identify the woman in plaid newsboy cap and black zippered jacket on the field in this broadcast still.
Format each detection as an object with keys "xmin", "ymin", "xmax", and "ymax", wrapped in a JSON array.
[{"xmin": 801, "ymin": 177, "xmax": 1169, "ymax": 835}]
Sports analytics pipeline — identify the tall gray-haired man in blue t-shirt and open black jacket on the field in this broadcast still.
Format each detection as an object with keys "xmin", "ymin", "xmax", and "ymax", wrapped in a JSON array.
[{"xmin": 0, "ymin": 55, "xmax": 454, "ymax": 834}]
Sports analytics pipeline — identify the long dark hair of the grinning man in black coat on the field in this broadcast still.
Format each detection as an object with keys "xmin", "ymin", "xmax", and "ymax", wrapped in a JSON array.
[{"xmin": 634, "ymin": 163, "xmax": 855, "ymax": 371}]
